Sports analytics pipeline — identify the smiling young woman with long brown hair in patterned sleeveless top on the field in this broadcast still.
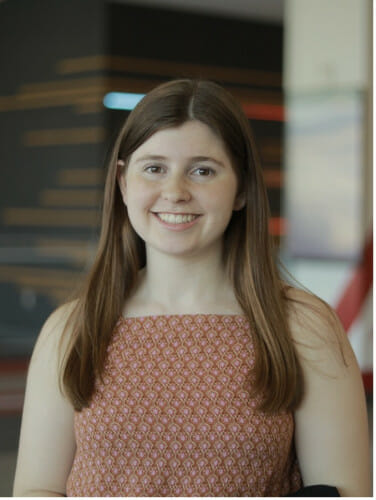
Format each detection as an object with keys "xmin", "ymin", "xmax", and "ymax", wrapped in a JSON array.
[{"xmin": 14, "ymin": 80, "xmax": 370, "ymax": 496}]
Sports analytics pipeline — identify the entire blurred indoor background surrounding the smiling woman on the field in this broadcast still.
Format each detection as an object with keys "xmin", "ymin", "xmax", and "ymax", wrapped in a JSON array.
[{"xmin": 0, "ymin": 0, "xmax": 373, "ymax": 496}]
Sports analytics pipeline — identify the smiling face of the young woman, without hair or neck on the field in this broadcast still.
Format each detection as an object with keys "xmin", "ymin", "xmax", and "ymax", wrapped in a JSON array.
[{"xmin": 118, "ymin": 121, "xmax": 244, "ymax": 256}]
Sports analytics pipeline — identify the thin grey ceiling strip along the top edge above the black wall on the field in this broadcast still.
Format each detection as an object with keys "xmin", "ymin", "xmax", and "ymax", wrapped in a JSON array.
[{"xmin": 110, "ymin": 0, "xmax": 284, "ymax": 24}]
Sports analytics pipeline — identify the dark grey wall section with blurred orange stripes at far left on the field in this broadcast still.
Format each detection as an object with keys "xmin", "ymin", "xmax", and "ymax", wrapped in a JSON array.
[{"xmin": 0, "ymin": 0, "xmax": 105, "ymax": 356}]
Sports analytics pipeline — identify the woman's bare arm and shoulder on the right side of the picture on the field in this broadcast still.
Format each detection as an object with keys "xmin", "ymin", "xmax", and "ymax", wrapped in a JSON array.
[{"xmin": 290, "ymin": 290, "xmax": 372, "ymax": 497}]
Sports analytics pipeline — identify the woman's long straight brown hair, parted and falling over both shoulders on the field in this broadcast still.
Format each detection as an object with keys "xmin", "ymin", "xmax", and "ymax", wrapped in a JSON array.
[{"xmin": 62, "ymin": 79, "xmax": 303, "ymax": 412}]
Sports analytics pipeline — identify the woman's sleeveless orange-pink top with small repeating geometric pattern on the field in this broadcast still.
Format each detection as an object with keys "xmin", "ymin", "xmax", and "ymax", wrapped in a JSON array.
[{"xmin": 66, "ymin": 314, "xmax": 302, "ymax": 497}]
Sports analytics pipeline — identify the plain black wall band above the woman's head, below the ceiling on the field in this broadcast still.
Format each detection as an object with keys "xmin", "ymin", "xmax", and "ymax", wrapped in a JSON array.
[{"xmin": 107, "ymin": 3, "xmax": 282, "ymax": 73}]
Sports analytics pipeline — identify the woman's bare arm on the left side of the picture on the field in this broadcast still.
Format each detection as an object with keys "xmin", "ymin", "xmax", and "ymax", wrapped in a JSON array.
[{"xmin": 13, "ymin": 305, "xmax": 75, "ymax": 496}]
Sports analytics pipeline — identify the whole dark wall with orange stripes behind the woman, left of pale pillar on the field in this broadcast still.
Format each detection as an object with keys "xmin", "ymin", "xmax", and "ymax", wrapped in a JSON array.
[{"xmin": 0, "ymin": 0, "xmax": 283, "ymax": 357}]
